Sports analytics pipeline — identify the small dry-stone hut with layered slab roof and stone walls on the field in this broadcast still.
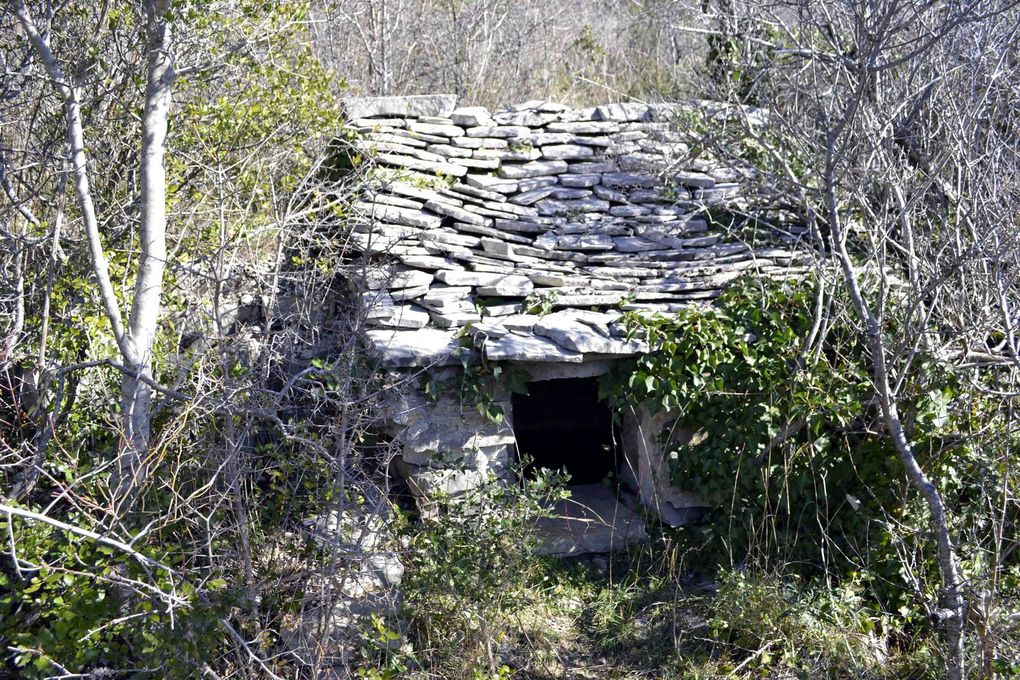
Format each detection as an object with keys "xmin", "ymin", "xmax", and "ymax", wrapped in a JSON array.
[{"xmin": 338, "ymin": 95, "xmax": 806, "ymax": 553}]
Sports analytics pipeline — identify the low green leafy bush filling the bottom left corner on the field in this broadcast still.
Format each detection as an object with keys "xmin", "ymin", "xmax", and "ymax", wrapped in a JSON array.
[{"xmin": 0, "ymin": 509, "xmax": 233, "ymax": 678}]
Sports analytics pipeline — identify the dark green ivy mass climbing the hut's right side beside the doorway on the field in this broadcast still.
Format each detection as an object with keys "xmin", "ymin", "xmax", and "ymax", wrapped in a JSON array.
[{"xmin": 602, "ymin": 279, "xmax": 975, "ymax": 591}]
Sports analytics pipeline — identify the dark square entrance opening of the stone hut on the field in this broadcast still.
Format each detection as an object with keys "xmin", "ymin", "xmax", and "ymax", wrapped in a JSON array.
[{"xmin": 511, "ymin": 378, "xmax": 619, "ymax": 485}]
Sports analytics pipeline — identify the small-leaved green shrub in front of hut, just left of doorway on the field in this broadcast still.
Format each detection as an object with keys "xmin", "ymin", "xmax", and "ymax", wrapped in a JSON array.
[{"xmin": 402, "ymin": 475, "xmax": 564, "ymax": 677}]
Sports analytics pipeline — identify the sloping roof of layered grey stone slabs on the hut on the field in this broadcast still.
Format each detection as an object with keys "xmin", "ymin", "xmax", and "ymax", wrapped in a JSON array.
[{"xmin": 345, "ymin": 95, "xmax": 804, "ymax": 366}]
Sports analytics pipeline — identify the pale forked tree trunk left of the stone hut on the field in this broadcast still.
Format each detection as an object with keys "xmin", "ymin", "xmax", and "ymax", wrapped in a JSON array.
[{"xmin": 14, "ymin": 0, "xmax": 174, "ymax": 501}]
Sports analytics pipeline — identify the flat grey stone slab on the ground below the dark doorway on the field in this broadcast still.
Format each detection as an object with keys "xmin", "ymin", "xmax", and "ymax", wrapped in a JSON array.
[{"xmin": 536, "ymin": 484, "xmax": 648, "ymax": 557}]
